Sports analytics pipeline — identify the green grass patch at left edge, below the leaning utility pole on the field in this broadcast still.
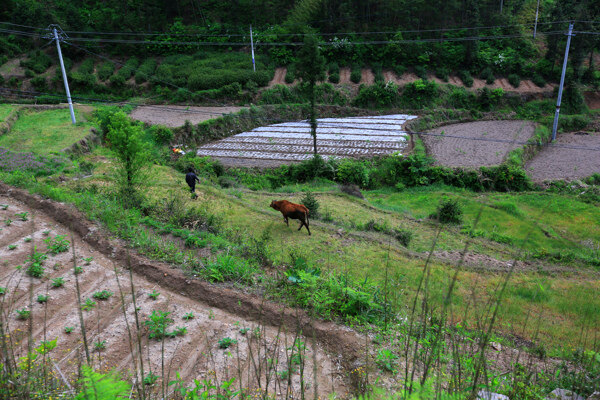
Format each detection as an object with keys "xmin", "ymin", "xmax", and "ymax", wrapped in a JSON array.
[{"xmin": 0, "ymin": 109, "xmax": 92, "ymax": 154}]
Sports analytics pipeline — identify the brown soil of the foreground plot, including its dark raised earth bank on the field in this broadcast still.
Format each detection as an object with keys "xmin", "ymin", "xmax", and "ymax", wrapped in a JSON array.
[{"xmin": 0, "ymin": 184, "xmax": 359, "ymax": 398}]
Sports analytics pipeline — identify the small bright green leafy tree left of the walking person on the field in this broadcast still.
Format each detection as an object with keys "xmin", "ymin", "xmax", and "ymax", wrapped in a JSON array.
[{"xmin": 106, "ymin": 111, "xmax": 149, "ymax": 204}]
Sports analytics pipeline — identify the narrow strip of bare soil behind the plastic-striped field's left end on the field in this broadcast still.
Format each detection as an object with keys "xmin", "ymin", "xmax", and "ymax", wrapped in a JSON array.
[{"xmin": 130, "ymin": 105, "xmax": 244, "ymax": 128}]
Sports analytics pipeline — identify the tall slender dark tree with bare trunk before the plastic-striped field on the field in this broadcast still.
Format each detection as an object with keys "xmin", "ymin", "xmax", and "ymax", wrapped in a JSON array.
[{"xmin": 296, "ymin": 35, "xmax": 325, "ymax": 155}]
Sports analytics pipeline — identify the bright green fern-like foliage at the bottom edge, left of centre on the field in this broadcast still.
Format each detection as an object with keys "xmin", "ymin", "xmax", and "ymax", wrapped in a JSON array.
[{"xmin": 75, "ymin": 365, "xmax": 131, "ymax": 400}]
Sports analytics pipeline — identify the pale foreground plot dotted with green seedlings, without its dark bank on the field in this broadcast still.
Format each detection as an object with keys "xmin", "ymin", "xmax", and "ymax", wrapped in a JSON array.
[{"xmin": 0, "ymin": 194, "xmax": 345, "ymax": 398}]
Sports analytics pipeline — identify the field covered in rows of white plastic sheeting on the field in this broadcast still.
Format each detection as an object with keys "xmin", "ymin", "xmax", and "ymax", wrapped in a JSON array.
[{"xmin": 197, "ymin": 114, "xmax": 417, "ymax": 167}]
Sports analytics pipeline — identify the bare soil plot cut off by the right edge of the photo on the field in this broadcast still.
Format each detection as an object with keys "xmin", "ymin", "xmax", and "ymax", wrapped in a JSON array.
[{"xmin": 525, "ymin": 132, "xmax": 600, "ymax": 182}]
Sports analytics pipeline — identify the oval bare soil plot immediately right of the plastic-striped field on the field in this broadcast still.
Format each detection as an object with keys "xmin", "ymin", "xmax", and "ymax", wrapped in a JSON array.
[{"xmin": 421, "ymin": 121, "xmax": 535, "ymax": 167}]
